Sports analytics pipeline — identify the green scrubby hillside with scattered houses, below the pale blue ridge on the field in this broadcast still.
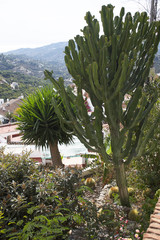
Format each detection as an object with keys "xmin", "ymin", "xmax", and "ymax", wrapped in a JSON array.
[{"xmin": 0, "ymin": 54, "xmax": 70, "ymax": 100}]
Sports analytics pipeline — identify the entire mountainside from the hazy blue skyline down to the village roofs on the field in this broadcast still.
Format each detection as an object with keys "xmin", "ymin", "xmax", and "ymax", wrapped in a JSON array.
[{"xmin": 0, "ymin": 43, "xmax": 70, "ymax": 99}]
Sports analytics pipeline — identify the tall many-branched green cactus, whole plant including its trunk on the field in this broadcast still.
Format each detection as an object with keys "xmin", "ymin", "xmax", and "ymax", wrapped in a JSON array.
[{"xmin": 45, "ymin": 5, "xmax": 160, "ymax": 206}]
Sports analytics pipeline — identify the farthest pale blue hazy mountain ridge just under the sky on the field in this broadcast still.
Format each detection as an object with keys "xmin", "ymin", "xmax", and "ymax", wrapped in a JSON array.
[{"xmin": 4, "ymin": 42, "xmax": 67, "ymax": 64}]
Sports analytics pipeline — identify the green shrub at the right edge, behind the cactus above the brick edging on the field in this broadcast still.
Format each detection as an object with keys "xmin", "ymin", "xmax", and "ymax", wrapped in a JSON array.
[{"xmin": 132, "ymin": 84, "xmax": 160, "ymax": 197}]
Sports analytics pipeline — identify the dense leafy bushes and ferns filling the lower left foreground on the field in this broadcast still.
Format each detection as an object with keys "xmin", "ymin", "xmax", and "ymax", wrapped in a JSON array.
[{"xmin": 0, "ymin": 149, "xmax": 117, "ymax": 240}]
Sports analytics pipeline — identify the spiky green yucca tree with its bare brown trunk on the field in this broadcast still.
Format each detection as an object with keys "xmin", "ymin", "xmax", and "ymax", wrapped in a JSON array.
[{"xmin": 15, "ymin": 87, "xmax": 72, "ymax": 167}]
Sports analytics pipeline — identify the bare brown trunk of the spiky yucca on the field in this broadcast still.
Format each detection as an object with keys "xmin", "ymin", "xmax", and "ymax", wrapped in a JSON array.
[{"xmin": 49, "ymin": 141, "xmax": 63, "ymax": 168}]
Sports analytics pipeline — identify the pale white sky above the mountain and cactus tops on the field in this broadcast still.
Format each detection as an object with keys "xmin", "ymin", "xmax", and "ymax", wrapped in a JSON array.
[{"xmin": 0, "ymin": 0, "xmax": 146, "ymax": 52}]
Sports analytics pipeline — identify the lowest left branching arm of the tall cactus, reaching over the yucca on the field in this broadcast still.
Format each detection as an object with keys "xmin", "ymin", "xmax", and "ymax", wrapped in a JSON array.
[{"xmin": 46, "ymin": 72, "xmax": 110, "ymax": 160}]
